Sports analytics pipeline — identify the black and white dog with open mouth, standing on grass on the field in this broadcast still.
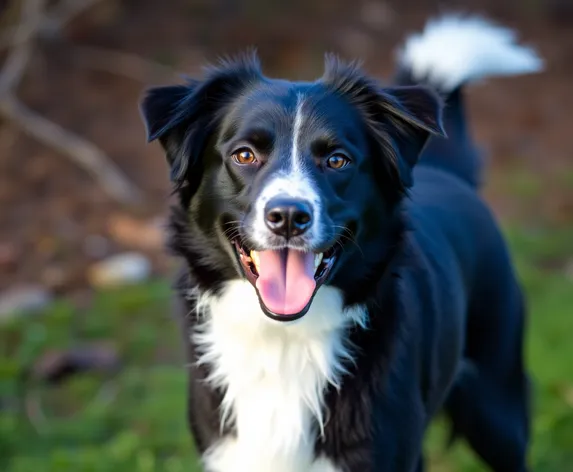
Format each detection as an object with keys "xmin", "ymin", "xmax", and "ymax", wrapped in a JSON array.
[{"xmin": 142, "ymin": 16, "xmax": 542, "ymax": 472}]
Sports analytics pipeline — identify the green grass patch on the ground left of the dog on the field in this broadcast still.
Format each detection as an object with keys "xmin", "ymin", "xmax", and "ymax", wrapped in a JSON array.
[{"xmin": 0, "ymin": 283, "xmax": 198, "ymax": 472}]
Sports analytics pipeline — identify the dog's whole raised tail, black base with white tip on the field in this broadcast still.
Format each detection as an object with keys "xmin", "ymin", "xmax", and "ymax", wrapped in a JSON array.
[{"xmin": 395, "ymin": 15, "xmax": 543, "ymax": 187}]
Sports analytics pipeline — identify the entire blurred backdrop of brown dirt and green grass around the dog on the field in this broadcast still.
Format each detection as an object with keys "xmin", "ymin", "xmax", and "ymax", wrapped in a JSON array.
[{"xmin": 0, "ymin": 0, "xmax": 573, "ymax": 472}]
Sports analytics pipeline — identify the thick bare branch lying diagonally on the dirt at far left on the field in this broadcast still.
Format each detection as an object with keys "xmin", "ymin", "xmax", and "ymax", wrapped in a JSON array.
[{"xmin": 0, "ymin": 95, "xmax": 142, "ymax": 205}]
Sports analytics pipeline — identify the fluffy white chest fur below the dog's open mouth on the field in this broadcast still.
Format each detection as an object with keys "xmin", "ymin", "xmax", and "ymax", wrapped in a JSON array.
[{"xmin": 193, "ymin": 280, "xmax": 365, "ymax": 472}]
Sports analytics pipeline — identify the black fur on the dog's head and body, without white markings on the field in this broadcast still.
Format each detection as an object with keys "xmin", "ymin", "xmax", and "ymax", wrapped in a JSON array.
[{"xmin": 142, "ymin": 48, "xmax": 529, "ymax": 472}]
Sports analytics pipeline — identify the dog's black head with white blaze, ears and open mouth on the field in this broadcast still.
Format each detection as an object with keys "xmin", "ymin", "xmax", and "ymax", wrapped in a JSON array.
[{"xmin": 142, "ymin": 56, "xmax": 442, "ymax": 321}]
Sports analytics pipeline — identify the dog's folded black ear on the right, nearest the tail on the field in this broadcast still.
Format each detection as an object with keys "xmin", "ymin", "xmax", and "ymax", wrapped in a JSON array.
[{"xmin": 378, "ymin": 86, "xmax": 446, "ymax": 187}]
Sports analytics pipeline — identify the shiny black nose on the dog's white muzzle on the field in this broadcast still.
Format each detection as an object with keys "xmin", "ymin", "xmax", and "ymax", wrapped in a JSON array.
[{"xmin": 265, "ymin": 198, "xmax": 312, "ymax": 238}]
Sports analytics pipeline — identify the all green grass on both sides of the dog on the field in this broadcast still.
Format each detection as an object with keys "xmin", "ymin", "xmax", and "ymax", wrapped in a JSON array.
[{"xmin": 0, "ymin": 228, "xmax": 573, "ymax": 472}]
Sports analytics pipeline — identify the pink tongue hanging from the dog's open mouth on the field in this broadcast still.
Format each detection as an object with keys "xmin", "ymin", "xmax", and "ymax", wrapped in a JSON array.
[{"xmin": 256, "ymin": 249, "xmax": 316, "ymax": 315}]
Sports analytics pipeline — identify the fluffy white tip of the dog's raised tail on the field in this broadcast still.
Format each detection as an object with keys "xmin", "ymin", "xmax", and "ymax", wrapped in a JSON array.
[{"xmin": 398, "ymin": 15, "xmax": 543, "ymax": 92}]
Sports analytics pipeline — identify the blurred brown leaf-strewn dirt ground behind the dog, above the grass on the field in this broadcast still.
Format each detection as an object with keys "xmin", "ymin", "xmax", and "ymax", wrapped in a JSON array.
[{"xmin": 0, "ymin": 0, "xmax": 573, "ymax": 293}]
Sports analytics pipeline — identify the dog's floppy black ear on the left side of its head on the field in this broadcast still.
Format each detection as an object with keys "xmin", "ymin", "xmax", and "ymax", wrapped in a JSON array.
[{"xmin": 140, "ymin": 53, "xmax": 262, "ymax": 188}]
